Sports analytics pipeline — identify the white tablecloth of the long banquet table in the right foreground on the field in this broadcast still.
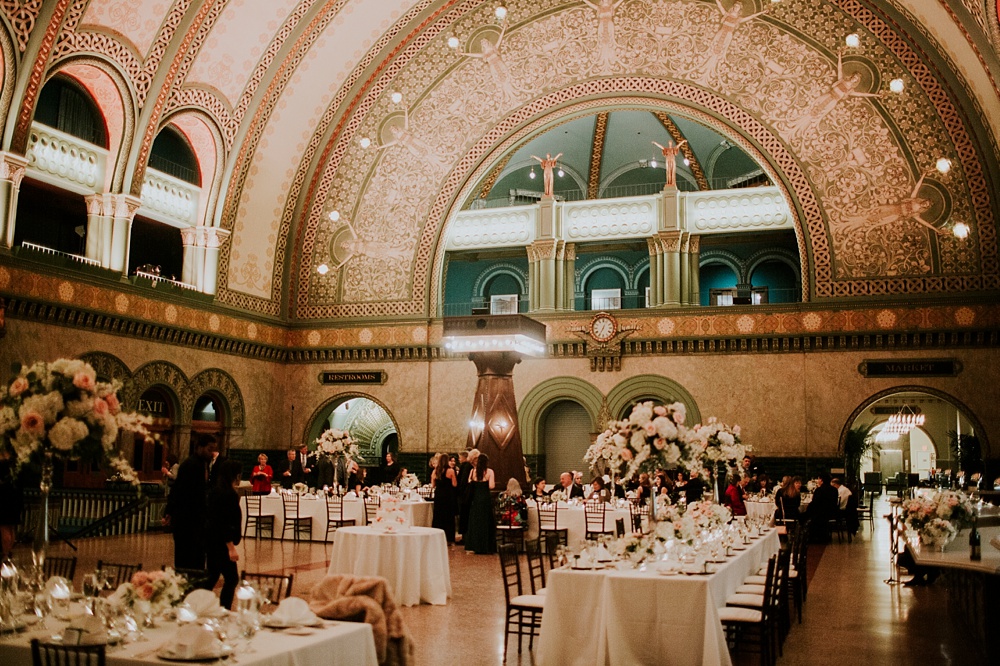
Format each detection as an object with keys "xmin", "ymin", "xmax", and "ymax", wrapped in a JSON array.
[{"xmin": 538, "ymin": 529, "xmax": 780, "ymax": 666}]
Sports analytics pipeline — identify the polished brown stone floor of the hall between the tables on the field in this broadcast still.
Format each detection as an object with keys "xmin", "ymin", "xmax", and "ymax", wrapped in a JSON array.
[{"xmin": 17, "ymin": 504, "xmax": 989, "ymax": 666}]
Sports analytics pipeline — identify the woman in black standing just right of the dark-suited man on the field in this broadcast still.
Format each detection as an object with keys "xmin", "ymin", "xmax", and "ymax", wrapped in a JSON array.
[{"xmin": 206, "ymin": 460, "xmax": 243, "ymax": 610}]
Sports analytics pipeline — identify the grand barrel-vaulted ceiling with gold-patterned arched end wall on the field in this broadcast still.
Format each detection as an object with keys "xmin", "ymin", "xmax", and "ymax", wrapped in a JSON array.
[{"xmin": 0, "ymin": 0, "xmax": 1000, "ymax": 319}]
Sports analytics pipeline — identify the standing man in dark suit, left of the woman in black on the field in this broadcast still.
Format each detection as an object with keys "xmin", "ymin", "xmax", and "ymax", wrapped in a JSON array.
[{"xmin": 163, "ymin": 434, "xmax": 218, "ymax": 570}]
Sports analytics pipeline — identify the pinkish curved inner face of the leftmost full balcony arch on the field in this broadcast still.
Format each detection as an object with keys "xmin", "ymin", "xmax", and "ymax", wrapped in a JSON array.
[{"xmin": 46, "ymin": 54, "xmax": 138, "ymax": 192}]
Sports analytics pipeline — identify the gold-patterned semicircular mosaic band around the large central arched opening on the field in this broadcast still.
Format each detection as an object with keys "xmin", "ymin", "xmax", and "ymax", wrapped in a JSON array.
[{"xmin": 296, "ymin": 0, "xmax": 996, "ymax": 318}]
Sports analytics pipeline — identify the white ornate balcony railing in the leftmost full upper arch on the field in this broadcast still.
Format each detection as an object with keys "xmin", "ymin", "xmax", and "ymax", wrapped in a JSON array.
[{"xmin": 27, "ymin": 123, "xmax": 108, "ymax": 194}]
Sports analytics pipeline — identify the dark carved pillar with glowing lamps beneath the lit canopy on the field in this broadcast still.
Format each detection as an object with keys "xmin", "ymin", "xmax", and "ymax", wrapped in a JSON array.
[{"xmin": 468, "ymin": 352, "xmax": 524, "ymax": 488}]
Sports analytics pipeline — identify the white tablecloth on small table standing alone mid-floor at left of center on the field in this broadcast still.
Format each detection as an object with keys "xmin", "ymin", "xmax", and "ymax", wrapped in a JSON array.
[{"xmin": 329, "ymin": 527, "xmax": 451, "ymax": 606}]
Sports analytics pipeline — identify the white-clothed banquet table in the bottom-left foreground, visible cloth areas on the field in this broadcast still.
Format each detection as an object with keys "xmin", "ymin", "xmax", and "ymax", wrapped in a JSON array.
[{"xmin": 0, "ymin": 619, "xmax": 378, "ymax": 666}]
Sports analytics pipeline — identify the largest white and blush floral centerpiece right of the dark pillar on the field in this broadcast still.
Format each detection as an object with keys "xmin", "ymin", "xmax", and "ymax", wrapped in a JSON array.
[{"xmin": 583, "ymin": 401, "xmax": 698, "ymax": 481}]
